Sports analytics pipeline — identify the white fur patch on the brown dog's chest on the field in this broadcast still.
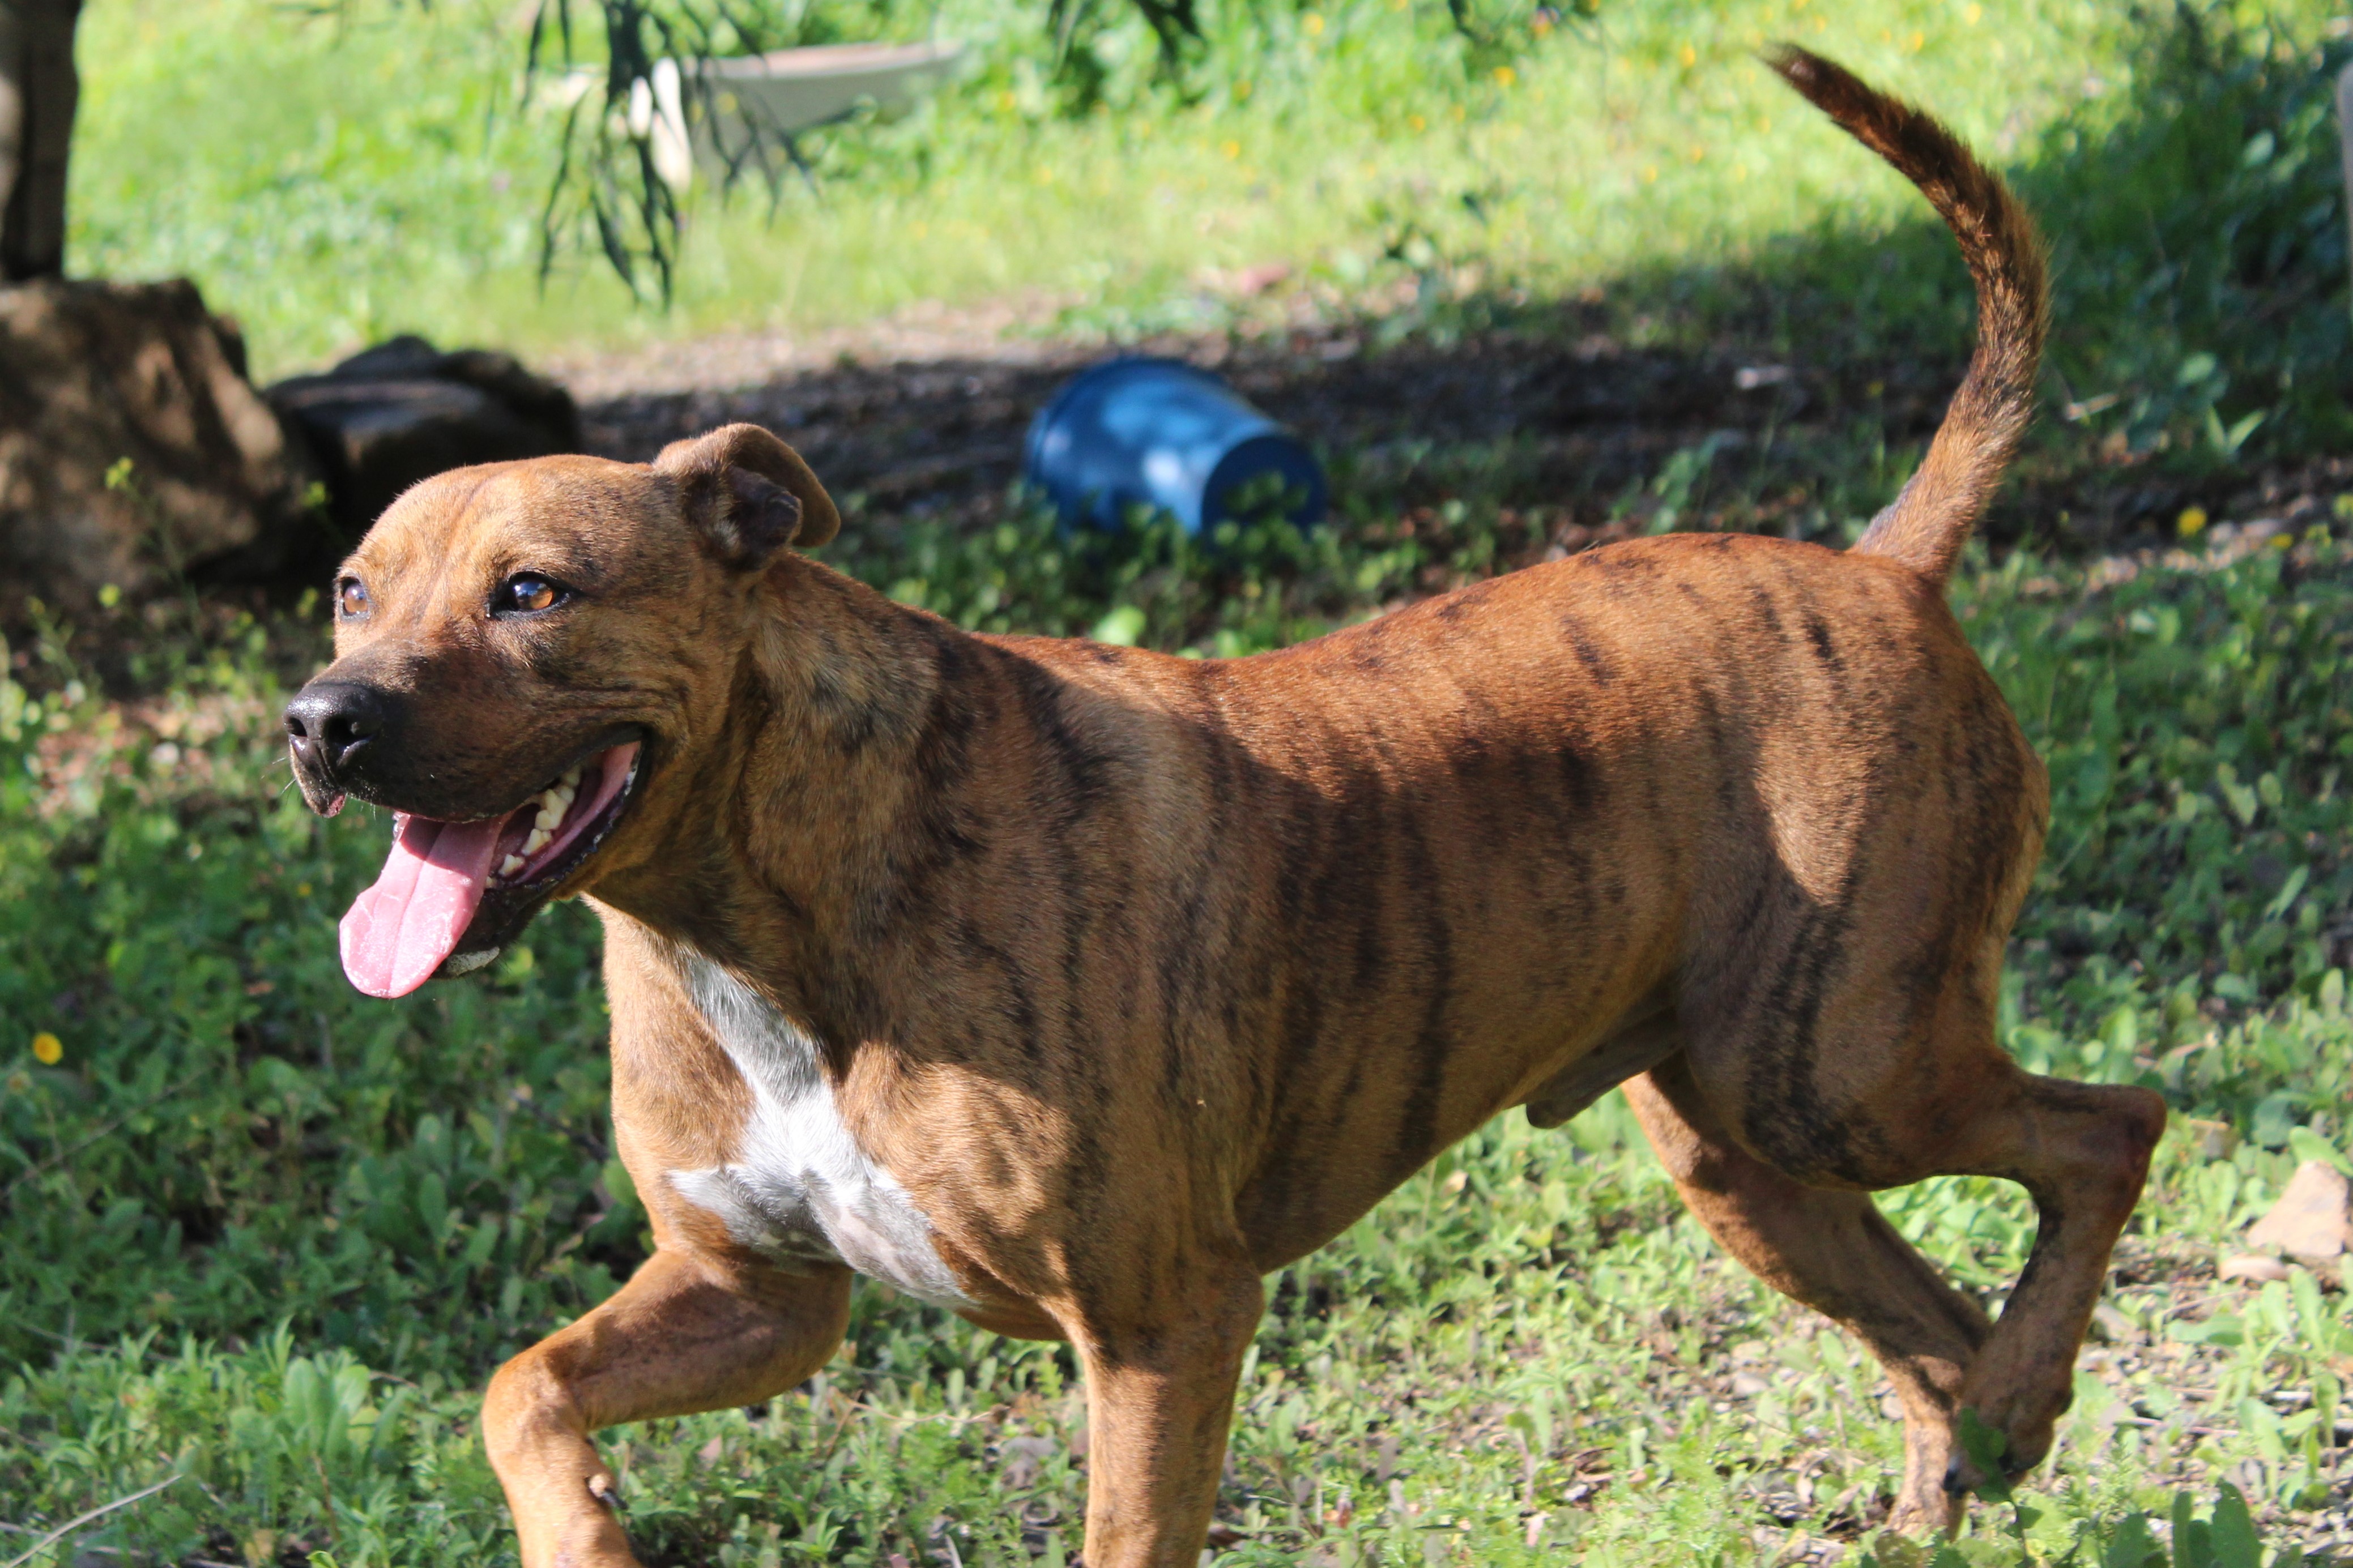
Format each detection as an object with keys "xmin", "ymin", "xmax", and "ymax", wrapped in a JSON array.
[{"xmin": 671, "ymin": 952, "xmax": 977, "ymax": 1307}]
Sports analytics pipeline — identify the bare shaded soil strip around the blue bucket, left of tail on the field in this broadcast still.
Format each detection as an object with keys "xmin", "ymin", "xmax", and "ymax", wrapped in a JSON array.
[{"xmin": 567, "ymin": 308, "xmax": 1911, "ymax": 533}]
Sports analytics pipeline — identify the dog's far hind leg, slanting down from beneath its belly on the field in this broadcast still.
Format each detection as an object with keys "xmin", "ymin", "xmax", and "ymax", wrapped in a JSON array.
[{"xmin": 1623, "ymin": 1053, "xmax": 1993, "ymax": 1533}]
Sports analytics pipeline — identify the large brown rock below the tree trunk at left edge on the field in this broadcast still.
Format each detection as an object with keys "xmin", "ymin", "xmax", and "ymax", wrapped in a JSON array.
[{"xmin": 0, "ymin": 277, "xmax": 310, "ymax": 618}]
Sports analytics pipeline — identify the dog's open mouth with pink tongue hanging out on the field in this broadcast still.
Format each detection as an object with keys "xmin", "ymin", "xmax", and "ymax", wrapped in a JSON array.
[{"xmin": 343, "ymin": 741, "xmax": 638, "ymax": 997}]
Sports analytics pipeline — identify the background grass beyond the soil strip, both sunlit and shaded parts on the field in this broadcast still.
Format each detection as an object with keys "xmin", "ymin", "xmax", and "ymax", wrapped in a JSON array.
[{"xmin": 71, "ymin": 0, "xmax": 2346, "ymax": 463}]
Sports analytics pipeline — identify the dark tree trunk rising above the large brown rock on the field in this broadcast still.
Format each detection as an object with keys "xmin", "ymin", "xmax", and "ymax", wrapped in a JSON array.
[{"xmin": 0, "ymin": 0, "xmax": 82, "ymax": 282}]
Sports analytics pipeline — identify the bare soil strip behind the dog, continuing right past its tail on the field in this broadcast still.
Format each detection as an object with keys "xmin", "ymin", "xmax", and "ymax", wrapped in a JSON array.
[{"xmin": 555, "ymin": 304, "xmax": 2353, "ymax": 555}]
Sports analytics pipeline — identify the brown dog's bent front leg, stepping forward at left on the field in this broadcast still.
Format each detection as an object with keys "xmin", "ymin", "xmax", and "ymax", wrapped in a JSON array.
[{"xmin": 483, "ymin": 1251, "xmax": 850, "ymax": 1568}]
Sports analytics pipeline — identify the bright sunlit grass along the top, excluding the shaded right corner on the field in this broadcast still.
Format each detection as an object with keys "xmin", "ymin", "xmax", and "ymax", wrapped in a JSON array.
[{"xmin": 73, "ymin": 0, "xmax": 2089, "ymax": 364}]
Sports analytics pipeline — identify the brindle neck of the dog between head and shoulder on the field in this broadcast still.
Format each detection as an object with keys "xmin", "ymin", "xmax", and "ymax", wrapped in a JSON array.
[{"xmin": 595, "ymin": 555, "xmax": 974, "ymax": 1041}]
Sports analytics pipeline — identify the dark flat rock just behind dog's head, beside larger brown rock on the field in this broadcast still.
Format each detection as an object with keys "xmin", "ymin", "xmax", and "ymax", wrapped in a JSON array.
[{"xmin": 266, "ymin": 336, "xmax": 581, "ymax": 541}]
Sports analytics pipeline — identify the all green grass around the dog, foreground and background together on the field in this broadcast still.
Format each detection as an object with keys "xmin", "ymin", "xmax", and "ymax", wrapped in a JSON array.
[{"xmin": 14, "ymin": 0, "xmax": 2353, "ymax": 1568}]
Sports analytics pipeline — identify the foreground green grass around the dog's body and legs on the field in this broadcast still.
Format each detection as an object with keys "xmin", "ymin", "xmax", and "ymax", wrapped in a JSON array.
[{"xmin": 0, "ymin": 510, "xmax": 2353, "ymax": 1568}]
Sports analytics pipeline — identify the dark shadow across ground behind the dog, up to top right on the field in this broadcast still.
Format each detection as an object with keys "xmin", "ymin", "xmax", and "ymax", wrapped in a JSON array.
[{"xmin": 574, "ymin": 0, "xmax": 2353, "ymax": 557}]
